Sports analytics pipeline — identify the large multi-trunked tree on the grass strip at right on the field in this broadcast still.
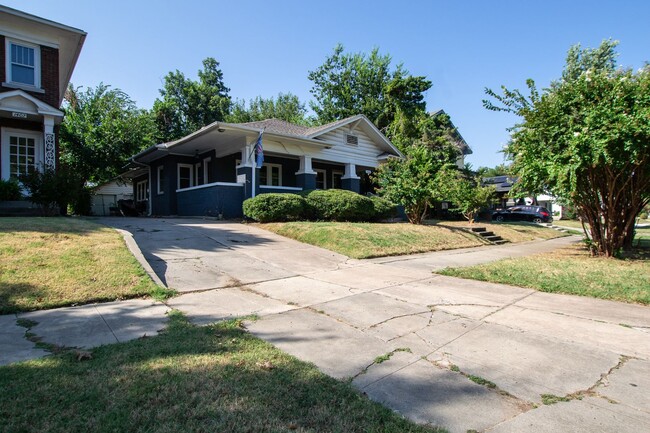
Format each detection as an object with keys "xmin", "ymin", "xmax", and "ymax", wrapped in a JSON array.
[{"xmin": 484, "ymin": 41, "xmax": 650, "ymax": 257}]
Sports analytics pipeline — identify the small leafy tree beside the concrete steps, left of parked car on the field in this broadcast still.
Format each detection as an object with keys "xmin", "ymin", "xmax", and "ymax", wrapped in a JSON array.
[{"xmin": 436, "ymin": 166, "xmax": 496, "ymax": 224}]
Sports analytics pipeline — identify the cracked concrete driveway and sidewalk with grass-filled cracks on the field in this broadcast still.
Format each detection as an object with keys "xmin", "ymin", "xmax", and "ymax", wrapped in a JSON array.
[{"xmin": 0, "ymin": 219, "xmax": 650, "ymax": 433}]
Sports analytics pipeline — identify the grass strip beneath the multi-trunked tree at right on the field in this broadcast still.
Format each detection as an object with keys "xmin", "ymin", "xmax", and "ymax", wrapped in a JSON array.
[{"xmin": 438, "ymin": 245, "xmax": 650, "ymax": 305}]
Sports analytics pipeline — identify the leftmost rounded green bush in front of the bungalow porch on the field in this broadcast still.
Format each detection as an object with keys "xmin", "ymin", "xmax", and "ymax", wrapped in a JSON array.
[{"xmin": 243, "ymin": 193, "xmax": 305, "ymax": 223}]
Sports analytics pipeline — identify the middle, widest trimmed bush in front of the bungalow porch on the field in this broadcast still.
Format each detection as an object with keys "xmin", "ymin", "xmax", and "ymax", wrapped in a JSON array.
[{"xmin": 305, "ymin": 189, "xmax": 375, "ymax": 221}]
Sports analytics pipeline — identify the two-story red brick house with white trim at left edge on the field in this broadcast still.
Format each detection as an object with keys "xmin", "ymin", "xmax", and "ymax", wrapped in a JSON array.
[{"xmin": 0, "ymin": 5, "xmax": 86, "ymax": 183}]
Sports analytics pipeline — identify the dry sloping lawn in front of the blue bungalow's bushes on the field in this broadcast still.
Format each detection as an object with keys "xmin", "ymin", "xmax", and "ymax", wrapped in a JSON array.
[{"xmin": 257, "ymin": 222, "xmax": 485, "ymax": 259}]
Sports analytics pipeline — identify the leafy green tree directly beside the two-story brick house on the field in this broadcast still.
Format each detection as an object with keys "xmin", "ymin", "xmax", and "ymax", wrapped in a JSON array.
[{"xmin": 59, "ymin": 83, "xmax": 155, "ymax": 185}]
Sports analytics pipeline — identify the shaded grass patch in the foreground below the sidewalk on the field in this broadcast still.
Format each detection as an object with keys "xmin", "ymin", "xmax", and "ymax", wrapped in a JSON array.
[{"xmin": 0, "ymin": 312, "xmax": 443, "ymax": 433}]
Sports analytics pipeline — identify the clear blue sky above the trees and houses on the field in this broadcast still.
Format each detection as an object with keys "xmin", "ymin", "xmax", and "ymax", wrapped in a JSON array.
[{"xmin": 3, "ymin": 0, "xmax": 650, "ymax": 168}]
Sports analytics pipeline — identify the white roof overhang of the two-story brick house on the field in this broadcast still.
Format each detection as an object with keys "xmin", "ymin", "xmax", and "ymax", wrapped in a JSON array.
[{"xmin": 0, "ymin": 5, "xmax": 86, "ymax": 105}]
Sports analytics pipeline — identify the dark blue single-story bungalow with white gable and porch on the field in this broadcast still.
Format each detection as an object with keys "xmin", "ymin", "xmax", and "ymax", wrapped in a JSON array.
[{"xmin": 123, "ymin": 115, "xmax": 403, "ymax": 218}]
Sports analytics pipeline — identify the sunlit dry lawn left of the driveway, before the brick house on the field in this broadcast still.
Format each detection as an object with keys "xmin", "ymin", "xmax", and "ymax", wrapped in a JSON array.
[{"xmin": 0, "ymin": 217, "xmax": 172, "ymax": 314}]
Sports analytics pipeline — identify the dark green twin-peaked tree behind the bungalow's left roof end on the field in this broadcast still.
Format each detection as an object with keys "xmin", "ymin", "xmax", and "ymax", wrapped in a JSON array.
[{"xmin": 153, "ymin": 57, "xmax": 231, "ymax": 141}]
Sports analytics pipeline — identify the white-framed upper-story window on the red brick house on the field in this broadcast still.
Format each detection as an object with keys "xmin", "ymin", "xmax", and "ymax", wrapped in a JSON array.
[{"xmin": 6, "ymin": 39, "xmax": 41, "ymax": 87}]
